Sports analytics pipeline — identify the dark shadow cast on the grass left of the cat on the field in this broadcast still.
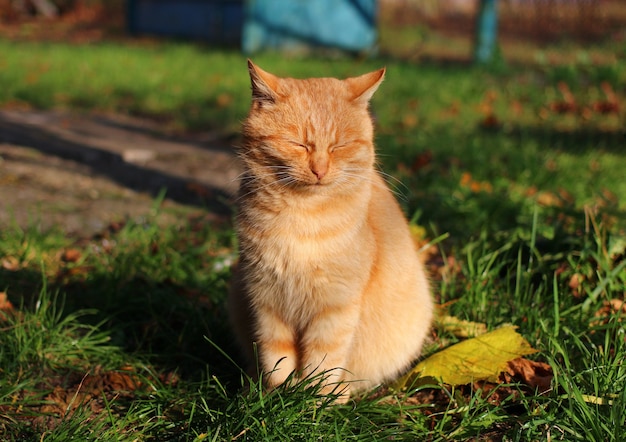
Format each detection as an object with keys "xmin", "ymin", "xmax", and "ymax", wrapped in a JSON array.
[{"xmin": 0, "ymin": 258, "xmax": 240, "ymax": 385}]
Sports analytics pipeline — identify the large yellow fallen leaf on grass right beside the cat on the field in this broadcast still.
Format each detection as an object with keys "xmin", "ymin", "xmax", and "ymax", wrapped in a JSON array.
[{"xmin": 393, "ymin": 326, "xmax": 537, "ymax": 390}]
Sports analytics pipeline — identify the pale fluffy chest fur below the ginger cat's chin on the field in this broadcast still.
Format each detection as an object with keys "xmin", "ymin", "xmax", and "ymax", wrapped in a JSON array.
[{"xmin": 238, "ymin": 187, "xmax": 375, "ymax": 322}]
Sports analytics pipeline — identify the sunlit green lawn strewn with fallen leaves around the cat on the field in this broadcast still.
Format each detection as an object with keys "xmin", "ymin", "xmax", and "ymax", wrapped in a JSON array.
[{"xmin": 0, "ymin": 30, "xmax": 626, "ymax": 441}]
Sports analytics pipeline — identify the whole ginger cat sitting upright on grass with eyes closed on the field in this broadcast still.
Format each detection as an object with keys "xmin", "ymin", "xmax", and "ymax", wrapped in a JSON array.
[{"xmin": 229, "ymin": 61, "xmax": 433, "ymax": 401}]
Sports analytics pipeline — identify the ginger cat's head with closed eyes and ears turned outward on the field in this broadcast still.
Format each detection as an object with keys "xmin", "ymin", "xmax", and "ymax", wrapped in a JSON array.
[{"xmin": 242, "ymin": 61, "xmax": 385, "ymax": 193}]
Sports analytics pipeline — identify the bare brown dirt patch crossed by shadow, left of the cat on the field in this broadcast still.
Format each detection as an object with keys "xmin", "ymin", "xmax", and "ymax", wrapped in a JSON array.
[{"xmin": 0, "ymin": 111, "xmax": 240, "ymax": 236}]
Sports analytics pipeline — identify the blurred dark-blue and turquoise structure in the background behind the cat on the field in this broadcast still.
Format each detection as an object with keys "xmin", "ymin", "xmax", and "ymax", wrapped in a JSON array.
[{"xmin": 127, "ymin": 0, "xmax": 377, "ymax": 53}]
